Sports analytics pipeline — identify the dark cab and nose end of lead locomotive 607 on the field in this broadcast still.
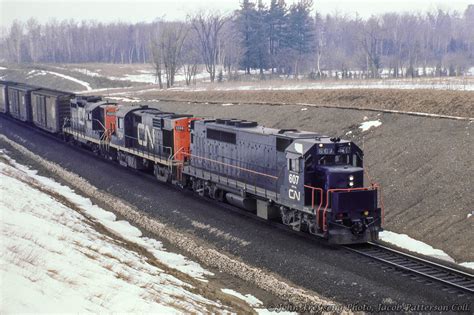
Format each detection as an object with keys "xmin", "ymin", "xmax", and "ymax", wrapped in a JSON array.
[{"xmin": 281, "ymin": 137, "xmax": 381, "ymax": 244}]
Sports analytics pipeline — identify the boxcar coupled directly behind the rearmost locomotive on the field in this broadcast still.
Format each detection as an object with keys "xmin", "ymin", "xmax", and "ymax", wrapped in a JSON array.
[{"xmin": 31, "ymin": 89, "xmax": 74, "ymax": 133}]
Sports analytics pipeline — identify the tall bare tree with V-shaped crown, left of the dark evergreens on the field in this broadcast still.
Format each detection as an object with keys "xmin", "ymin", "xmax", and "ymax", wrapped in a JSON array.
[{"xmin": 191, "ymin": 13, "xmax": 227, "ymax": 82}]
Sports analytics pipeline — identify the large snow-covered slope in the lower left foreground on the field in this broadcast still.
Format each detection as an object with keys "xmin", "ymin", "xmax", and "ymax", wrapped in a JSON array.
[{"xmin": 0, "ymin": 152, "xmax": 270, "ymax": 314}]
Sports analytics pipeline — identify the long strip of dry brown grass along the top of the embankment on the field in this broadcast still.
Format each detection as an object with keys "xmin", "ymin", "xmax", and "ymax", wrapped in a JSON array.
[{"xmin": 140, "ymin": 89, "xmax": 474, "ymax": 117}]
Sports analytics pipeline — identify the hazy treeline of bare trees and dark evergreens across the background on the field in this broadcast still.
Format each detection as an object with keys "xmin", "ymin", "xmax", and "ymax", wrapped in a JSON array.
[{"xmin": 0, "ymin": 0, "xmax": 474, "ymax": 86}]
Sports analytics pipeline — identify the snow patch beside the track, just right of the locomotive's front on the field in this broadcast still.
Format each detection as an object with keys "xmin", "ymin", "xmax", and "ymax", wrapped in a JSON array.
[{"xmin": 379, "ymin": 231, "xmax": 454, "ymax": 262}]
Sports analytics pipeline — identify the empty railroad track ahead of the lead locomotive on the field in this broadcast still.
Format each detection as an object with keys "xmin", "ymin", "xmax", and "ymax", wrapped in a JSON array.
[{"xmin": 344, "ymin": 243, "xmax": 474, "ymax": 296}]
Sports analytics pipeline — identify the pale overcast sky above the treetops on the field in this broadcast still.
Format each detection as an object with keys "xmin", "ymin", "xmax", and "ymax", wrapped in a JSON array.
[{"xmin": 0, "ymin": 0, "xmax": 474, "ymax": 27}]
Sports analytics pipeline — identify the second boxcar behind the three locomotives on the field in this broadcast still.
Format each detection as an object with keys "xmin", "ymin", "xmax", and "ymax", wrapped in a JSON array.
[{"xmin": 7, "ymin": 84, "xmax": 38, "ymax": 122}]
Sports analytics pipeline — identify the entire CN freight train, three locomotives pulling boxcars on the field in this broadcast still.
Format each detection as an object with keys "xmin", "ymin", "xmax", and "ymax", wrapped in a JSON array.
[{"xmin": 0, "ymin": 81, "xmax": 383, "ymax": 244}]
